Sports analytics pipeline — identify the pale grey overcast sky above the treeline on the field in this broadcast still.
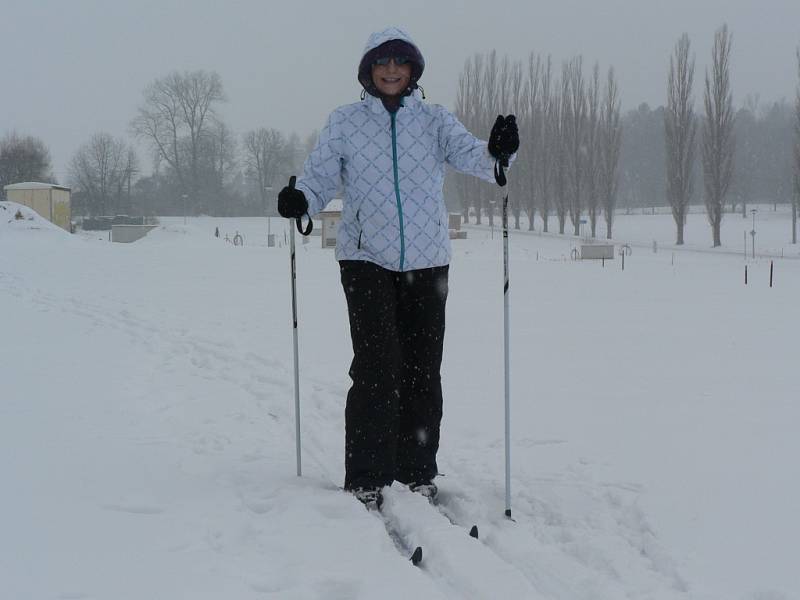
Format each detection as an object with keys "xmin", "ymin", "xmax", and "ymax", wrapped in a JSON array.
[{"xmin": 0, "ymin": 0, "xmax": 800, "ymax": 182}]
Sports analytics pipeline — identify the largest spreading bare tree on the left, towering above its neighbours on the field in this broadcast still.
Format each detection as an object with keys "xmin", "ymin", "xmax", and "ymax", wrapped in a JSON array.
[{"xmin": 131, "ymin": 71, "xmax": 225, "ymax": 204}]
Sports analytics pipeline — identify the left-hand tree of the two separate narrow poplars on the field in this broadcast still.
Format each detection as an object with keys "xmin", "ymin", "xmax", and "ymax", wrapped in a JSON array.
[{"xmin": 664, "ymin": 33, "xmax": 697, "ymax": 246}]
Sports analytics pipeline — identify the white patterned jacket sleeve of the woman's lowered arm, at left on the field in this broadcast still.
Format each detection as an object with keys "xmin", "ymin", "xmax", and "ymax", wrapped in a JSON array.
[{"xmin": 296, "ymin": 111, "xmax": 342, "ymax": 217}]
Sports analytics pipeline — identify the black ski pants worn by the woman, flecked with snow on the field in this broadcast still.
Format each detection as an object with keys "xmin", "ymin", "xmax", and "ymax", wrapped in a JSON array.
[{"xmin": 339, "ymin": 260, "xmax": 449, "ymax": 489}]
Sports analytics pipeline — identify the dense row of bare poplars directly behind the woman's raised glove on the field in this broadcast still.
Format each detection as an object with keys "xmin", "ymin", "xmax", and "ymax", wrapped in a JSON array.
[{"xmin": 453, "ymin": 51, "xmax": 622, "ymax": 238}]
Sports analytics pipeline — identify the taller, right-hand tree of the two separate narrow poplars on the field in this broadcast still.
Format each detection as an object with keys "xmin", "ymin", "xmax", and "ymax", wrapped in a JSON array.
[{"xmin": 703, "ymin": 25, "xmax": 734, "ymax": 247}]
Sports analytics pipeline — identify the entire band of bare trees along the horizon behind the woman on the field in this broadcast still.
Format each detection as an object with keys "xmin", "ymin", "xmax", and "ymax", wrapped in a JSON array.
[{"xmin": 0, "ymin": 27, "xmax": 800, "ymax": 245}]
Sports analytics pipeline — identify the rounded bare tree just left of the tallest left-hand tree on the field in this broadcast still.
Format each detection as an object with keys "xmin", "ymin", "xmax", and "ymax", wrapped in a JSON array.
[{"xmin": 68, "ymin": 133, "xmax": 135, "ymax": 215}]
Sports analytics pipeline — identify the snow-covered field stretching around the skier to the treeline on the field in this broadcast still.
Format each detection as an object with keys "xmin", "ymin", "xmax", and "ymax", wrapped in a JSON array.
[{"xmin": 0, "ymin": 203, "xmax": 800, "ymax": 600}]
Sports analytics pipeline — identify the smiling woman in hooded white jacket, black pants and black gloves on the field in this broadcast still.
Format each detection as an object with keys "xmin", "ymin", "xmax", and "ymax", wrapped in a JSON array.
[{"xmin": 278, "ymin": 27, "xmax": 519, "ymax": 508}]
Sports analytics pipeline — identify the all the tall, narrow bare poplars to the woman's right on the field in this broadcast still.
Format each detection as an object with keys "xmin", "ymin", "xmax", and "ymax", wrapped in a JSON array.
[{"xmin": 449, "ymin": 26, "xmax": 800, "ymax": 247}]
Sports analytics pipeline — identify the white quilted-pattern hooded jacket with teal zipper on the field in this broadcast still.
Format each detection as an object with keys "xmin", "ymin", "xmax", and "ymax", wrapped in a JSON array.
[{"xmin": 297, "ymin": 29, "xmax": 495, "ymax": 271}]
